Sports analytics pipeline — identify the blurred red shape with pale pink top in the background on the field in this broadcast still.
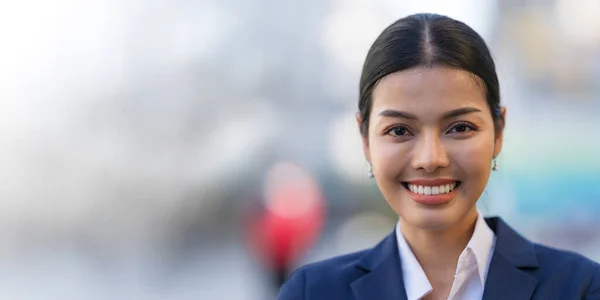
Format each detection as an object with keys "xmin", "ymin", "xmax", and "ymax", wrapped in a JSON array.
[{"xmin": 248, "ymin": 164, "xmax": 324, "ymax": 282}]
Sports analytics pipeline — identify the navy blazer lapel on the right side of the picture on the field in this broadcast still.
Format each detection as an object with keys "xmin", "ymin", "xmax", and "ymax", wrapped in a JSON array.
[{"xmin": 483, "ymin": 218, "xmax": 538, "ymax": 300}]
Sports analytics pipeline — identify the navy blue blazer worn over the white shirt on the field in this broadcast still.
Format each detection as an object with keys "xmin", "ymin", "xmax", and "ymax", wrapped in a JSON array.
[{"xmin": 278, "ymin": 217, "xmax": 600, "ymax": 300}]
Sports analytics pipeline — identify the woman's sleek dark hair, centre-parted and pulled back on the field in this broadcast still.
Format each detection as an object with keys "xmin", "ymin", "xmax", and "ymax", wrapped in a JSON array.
[{"xmin": 358, "ymin": 14, "xmax": 504, "ymax": 136}]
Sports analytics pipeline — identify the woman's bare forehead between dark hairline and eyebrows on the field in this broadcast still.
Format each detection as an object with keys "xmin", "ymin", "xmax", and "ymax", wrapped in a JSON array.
[{"xmin": 373, "ymin": 67, "xmax": 489, "ymax": 113}]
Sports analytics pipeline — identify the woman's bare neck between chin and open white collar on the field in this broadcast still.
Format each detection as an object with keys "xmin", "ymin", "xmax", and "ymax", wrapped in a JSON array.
[{"xmin": 400, "ymin": 207, "xmax": 477, "ymax": 280}]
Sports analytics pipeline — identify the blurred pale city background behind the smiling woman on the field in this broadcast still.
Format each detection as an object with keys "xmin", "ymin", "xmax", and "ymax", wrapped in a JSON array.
[{"xmin": 0, "ymin": 0, "xmax": 600, "ymax": 299}]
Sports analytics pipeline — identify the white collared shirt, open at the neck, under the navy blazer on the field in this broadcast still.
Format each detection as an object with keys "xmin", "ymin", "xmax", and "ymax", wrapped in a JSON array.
[{"xmin": 396, "ymin": 211, "xmax": 496, "ymax": 300}]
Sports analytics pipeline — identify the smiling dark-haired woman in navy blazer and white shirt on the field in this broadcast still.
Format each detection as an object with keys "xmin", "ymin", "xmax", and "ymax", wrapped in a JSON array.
[{"xmin": 279, "ymin": 14, "xmax": 600, "ymax": 300}]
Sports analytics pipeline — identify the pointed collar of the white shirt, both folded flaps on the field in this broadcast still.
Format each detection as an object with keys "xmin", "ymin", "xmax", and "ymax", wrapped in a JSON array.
[{"xmin": 395, "ymin": 210, "xmax": 496, "ymax": 300}]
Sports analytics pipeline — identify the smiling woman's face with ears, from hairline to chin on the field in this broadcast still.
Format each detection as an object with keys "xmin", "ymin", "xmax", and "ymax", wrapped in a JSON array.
[{"xmin": 358, "ymin": 67, "xmax": 504, "ymax": 230}]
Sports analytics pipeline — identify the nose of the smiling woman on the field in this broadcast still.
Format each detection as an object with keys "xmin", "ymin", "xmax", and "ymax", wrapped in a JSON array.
[{"xmin": 411, "ymin": 132, "xmax": 450, "ymax": 173}]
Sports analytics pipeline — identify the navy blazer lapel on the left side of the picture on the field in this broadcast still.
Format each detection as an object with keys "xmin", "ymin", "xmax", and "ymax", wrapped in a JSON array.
[{"xmin": 351, "ymin": 232, "xmax": 407, "ymax": 300}]
